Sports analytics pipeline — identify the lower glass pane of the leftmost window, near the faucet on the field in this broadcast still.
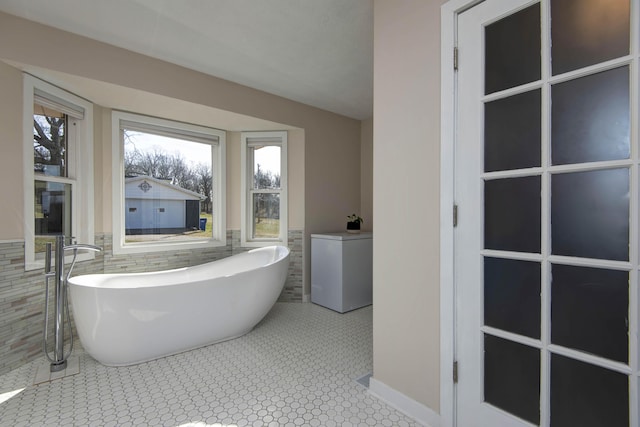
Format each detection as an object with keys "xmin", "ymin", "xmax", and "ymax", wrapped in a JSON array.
[{"xmin": 34, "ymin": 180, "xmax": 71, "ymax": 253}]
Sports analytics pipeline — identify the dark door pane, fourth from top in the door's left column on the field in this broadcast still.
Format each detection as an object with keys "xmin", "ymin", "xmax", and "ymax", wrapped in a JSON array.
[{"xmin": 484, "ymin": 257, "xmax": 540, "ymax": 338}]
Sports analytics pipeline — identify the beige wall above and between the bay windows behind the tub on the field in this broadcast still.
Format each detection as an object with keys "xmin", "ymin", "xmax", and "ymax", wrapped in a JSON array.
[{"xmin": 0, "ymin": 13, "xmax": 361, "ymax": 294}]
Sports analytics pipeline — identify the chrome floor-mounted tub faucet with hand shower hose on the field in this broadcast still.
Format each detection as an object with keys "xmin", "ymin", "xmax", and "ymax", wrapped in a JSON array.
[{"xmin": 42, "ymin": 236, "xmax": 102, "ymax": 372}]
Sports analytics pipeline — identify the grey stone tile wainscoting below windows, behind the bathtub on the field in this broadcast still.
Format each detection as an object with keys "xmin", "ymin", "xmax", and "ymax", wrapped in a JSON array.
[{"xmin": 0, "ymin": 230, "xmax": 304, "ymax": 375}]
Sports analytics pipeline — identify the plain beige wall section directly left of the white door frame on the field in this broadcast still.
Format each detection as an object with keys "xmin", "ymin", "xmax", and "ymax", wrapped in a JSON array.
[{"xmin": 373, "ymin": 0, "xmax": 444, "ymax": 412}]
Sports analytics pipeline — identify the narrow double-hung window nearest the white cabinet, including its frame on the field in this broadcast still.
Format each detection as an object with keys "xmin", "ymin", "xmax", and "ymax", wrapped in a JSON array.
[{"xmin": 240, "ymin": 132, "xmax": 288, "ymax": 247}]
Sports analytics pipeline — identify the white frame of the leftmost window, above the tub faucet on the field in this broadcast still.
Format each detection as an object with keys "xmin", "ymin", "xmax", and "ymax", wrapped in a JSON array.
[{"xmin": 22, "ymin": 73, "xmax": 95, "ymax": 270}]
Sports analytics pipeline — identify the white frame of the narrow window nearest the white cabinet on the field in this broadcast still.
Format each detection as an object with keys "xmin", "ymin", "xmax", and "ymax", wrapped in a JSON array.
[{"xmin": 240, "ymin": 131, "xmax": 289, "ymax": 247}]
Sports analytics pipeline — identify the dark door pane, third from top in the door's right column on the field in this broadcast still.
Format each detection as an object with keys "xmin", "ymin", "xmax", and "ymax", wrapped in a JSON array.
[{"xmin": 551, "ymin": 168, "xmax": 629, "ymax": 261}]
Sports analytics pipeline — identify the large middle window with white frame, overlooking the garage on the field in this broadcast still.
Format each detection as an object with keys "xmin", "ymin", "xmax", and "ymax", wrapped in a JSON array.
[{"xmin": 112, "ymin": 112, "xmax": 227, "ymax": 253}]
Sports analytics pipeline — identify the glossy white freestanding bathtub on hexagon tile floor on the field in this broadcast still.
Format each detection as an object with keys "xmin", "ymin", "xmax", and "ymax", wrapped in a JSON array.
[{"xmin": 69, "ymin": 246, "xmax": 289, "ymax": 366}]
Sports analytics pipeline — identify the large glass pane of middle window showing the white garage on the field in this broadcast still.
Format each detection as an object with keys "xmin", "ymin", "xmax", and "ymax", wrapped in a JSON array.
[{"xmin": 123, "ymin": 129, "xmax": 216, "ymax": 243}]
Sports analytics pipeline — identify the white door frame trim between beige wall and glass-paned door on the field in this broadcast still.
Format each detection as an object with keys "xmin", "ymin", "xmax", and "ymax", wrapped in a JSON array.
[{"xmin": 440, "ymin": 0, "xmax": 484, "ymax": 427}]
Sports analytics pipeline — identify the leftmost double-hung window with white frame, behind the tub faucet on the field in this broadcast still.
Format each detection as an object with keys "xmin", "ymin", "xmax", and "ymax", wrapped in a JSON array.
[{"xmin": 23, "ymin": 74, "xmax": 94, "ymax": 270}]
